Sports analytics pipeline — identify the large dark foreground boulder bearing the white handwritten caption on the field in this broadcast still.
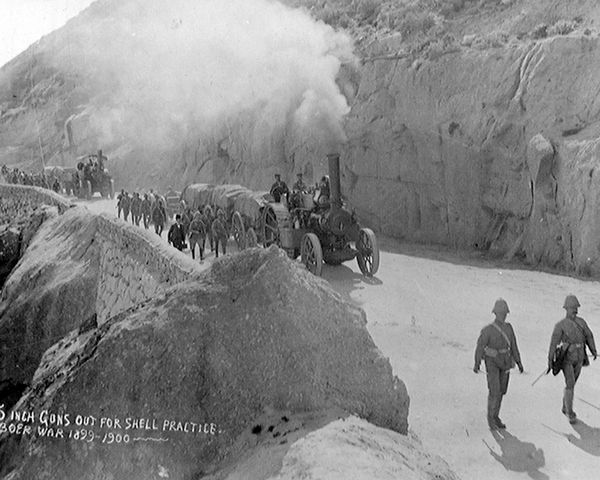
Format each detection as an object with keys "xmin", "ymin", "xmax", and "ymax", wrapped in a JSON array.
[{"xmin": 0, "ymin": 247, "xmax": 409, "ymax": 480}]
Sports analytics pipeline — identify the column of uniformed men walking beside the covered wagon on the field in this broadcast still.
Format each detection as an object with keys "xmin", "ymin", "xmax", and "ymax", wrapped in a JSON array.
[{"xmin": 117, "ymin": 189, "xmax": 230, "ymax": 261}]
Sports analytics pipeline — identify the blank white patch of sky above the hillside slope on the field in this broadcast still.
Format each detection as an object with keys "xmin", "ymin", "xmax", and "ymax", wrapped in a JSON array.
[{"xmin": 0, "ymin": 0, "xmax": 94, "ymax": 67}]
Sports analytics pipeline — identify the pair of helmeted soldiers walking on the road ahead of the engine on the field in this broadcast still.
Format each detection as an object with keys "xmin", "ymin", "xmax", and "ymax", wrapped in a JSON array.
[{"xmin": 473, "ymin": 295, "xmax": 598, "ymax": 430}]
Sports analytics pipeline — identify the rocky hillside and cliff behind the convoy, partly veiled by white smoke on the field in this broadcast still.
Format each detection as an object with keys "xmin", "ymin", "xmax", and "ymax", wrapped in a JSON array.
[{"xmin": 0, "ymin": 0, "xmax": 600, "ymax": 275}]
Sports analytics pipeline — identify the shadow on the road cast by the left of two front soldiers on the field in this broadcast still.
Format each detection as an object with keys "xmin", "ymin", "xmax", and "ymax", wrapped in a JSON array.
[{"xmin": 490, "ymin": 430, "xmax": 550, "ymax": 480}]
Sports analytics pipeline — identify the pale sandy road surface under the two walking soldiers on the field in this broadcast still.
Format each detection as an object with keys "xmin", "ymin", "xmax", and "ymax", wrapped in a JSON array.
[{"xmin": 77, "ymin": 198, "xmax": 600, "ymax": 480}]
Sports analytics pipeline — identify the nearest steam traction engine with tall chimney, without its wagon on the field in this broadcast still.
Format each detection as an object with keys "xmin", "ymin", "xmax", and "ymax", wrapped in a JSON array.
[{"xmin": 260, "ymin": 154, "xmax": 379, "ymax": 276}]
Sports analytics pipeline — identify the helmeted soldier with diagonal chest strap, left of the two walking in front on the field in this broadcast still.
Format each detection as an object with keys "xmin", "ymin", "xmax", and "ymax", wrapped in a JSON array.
[{"xmin": 473, "ymin": 298, "xmax": 523, "ymax": 430}]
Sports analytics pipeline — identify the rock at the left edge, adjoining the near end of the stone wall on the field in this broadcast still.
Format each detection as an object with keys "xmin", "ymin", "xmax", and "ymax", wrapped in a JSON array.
[{"xmin": 0, "ymin": 208, "xmax": 99, "ymax": 384}]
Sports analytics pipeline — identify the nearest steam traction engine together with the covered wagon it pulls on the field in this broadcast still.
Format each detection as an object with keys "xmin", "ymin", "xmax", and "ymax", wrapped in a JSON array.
[{"xmin": 181, "ymin": 154, "xmax": 379, "ymax": 276}]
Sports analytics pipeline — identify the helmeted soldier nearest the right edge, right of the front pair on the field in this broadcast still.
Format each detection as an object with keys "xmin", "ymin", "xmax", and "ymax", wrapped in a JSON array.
[{"xmin": 548, "ymin": 295, "xmax": 598, "ymax": 423}]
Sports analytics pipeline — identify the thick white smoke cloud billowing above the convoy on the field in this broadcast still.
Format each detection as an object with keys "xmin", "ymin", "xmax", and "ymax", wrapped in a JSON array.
[{"xmin": 54, "ymin": 0, "xmax": 352, "ymax": 156}]
